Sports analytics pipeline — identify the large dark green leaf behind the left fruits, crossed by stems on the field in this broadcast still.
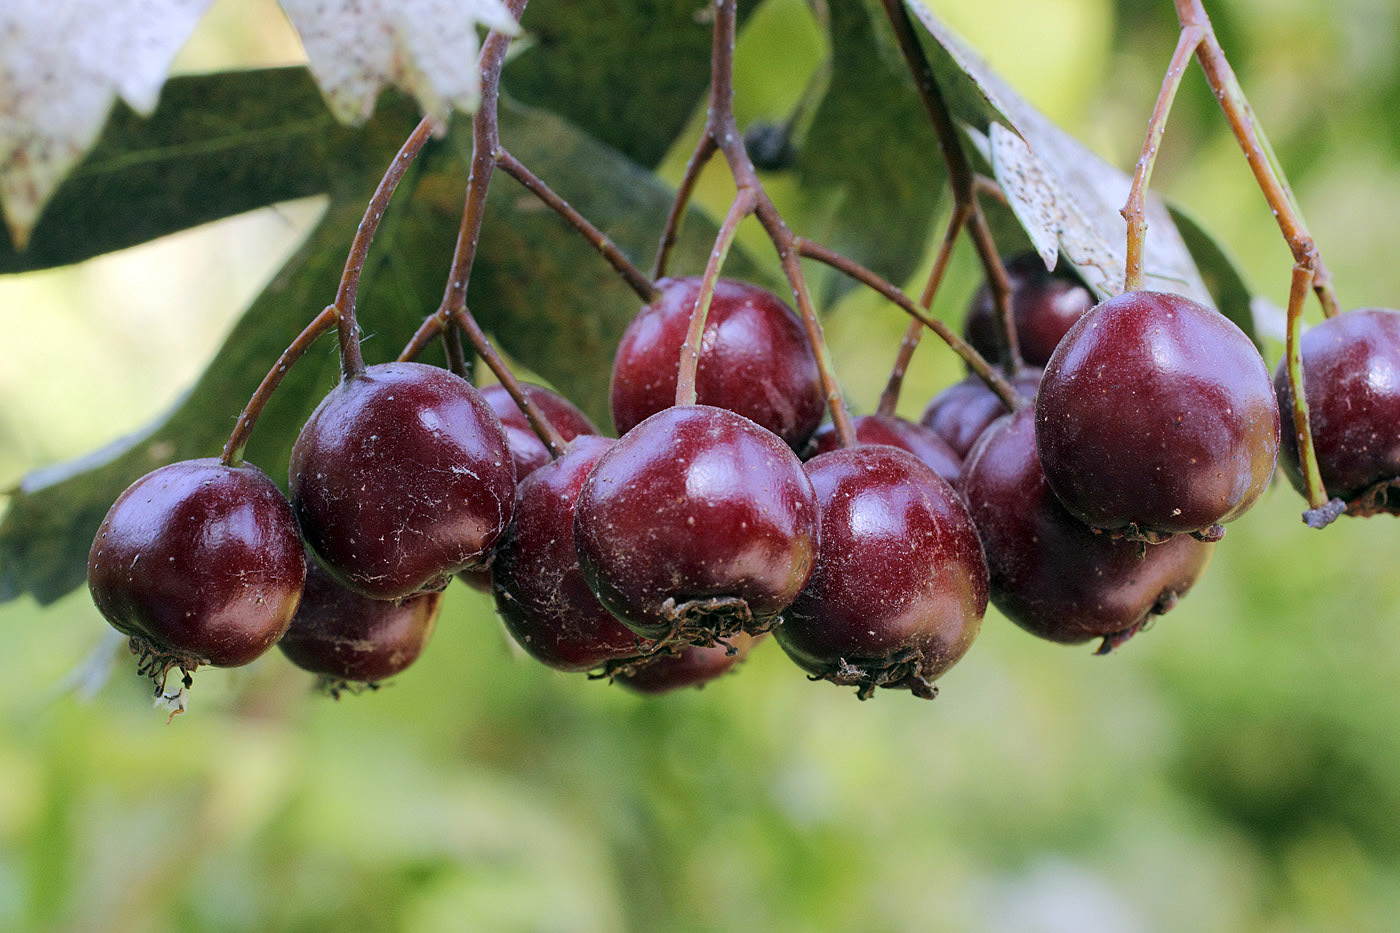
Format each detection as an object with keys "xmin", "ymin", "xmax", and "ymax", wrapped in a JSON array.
[{"xmin": 0, "ymin": 83, "xmax": 762, "ymax": 602}]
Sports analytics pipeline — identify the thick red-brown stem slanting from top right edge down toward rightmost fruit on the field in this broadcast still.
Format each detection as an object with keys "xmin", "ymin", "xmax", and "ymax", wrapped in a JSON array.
[{"xmin": 1175, "ymin": 0, "xmax": 1338, "ymax": 317}]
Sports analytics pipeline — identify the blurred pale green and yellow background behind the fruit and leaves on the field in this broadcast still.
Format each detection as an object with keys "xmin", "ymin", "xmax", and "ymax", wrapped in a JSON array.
[{"xmin": 0, "ymin": 0, "xmax": 1400, "ymax": 932}]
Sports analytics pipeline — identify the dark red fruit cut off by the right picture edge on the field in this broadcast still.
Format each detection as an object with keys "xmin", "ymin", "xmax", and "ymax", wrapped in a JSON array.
[{"xmin": 1274, "ymin": 308, "xmax": 1400, "ymax": 516}]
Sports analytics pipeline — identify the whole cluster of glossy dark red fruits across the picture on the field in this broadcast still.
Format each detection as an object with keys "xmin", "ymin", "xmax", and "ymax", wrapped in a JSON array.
[{"xmin": 88, "ymin": 232, "xmax": 1400, "ymax": 711}]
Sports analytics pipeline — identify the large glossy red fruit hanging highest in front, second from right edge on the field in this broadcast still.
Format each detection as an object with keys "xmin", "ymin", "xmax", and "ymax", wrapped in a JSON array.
[{"xmin": 1036, "ymin": 291, "xmax": 1278, "ymax": 542}]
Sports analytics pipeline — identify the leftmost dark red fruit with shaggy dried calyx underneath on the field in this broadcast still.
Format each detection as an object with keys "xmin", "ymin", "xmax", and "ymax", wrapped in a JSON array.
[{"xmin": 88, "ymin": 459, "xmax": 307, "ymax": 688}]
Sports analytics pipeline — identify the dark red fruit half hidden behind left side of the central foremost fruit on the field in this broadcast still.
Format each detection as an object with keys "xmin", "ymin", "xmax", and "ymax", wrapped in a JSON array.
[{"xmin": 491, "ymin": 434, "xmax": 650, "ymax": 671}]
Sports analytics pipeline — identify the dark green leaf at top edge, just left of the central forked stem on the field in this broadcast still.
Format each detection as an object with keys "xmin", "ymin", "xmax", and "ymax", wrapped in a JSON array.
[{"xmin": 501, "ymin": 0, "xmax": 750, "ymax": 168}]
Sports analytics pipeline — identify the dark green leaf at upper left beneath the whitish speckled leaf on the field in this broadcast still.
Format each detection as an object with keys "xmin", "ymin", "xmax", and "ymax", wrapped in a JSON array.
[{"xmin": 0, "ymin": 67, "xmax": 358, "ymax": 272}]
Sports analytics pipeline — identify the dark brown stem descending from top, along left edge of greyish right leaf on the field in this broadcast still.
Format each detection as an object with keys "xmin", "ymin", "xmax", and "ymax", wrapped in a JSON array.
[{"xmin": 883, "ymin": 0, "xmax": 1021, "ymax": 373}]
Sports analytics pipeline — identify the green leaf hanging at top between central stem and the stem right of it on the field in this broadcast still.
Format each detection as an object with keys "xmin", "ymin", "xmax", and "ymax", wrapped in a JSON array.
[{"xmin": 797, "ymin": 1, "xmax": 946, "ymax": 303}]
